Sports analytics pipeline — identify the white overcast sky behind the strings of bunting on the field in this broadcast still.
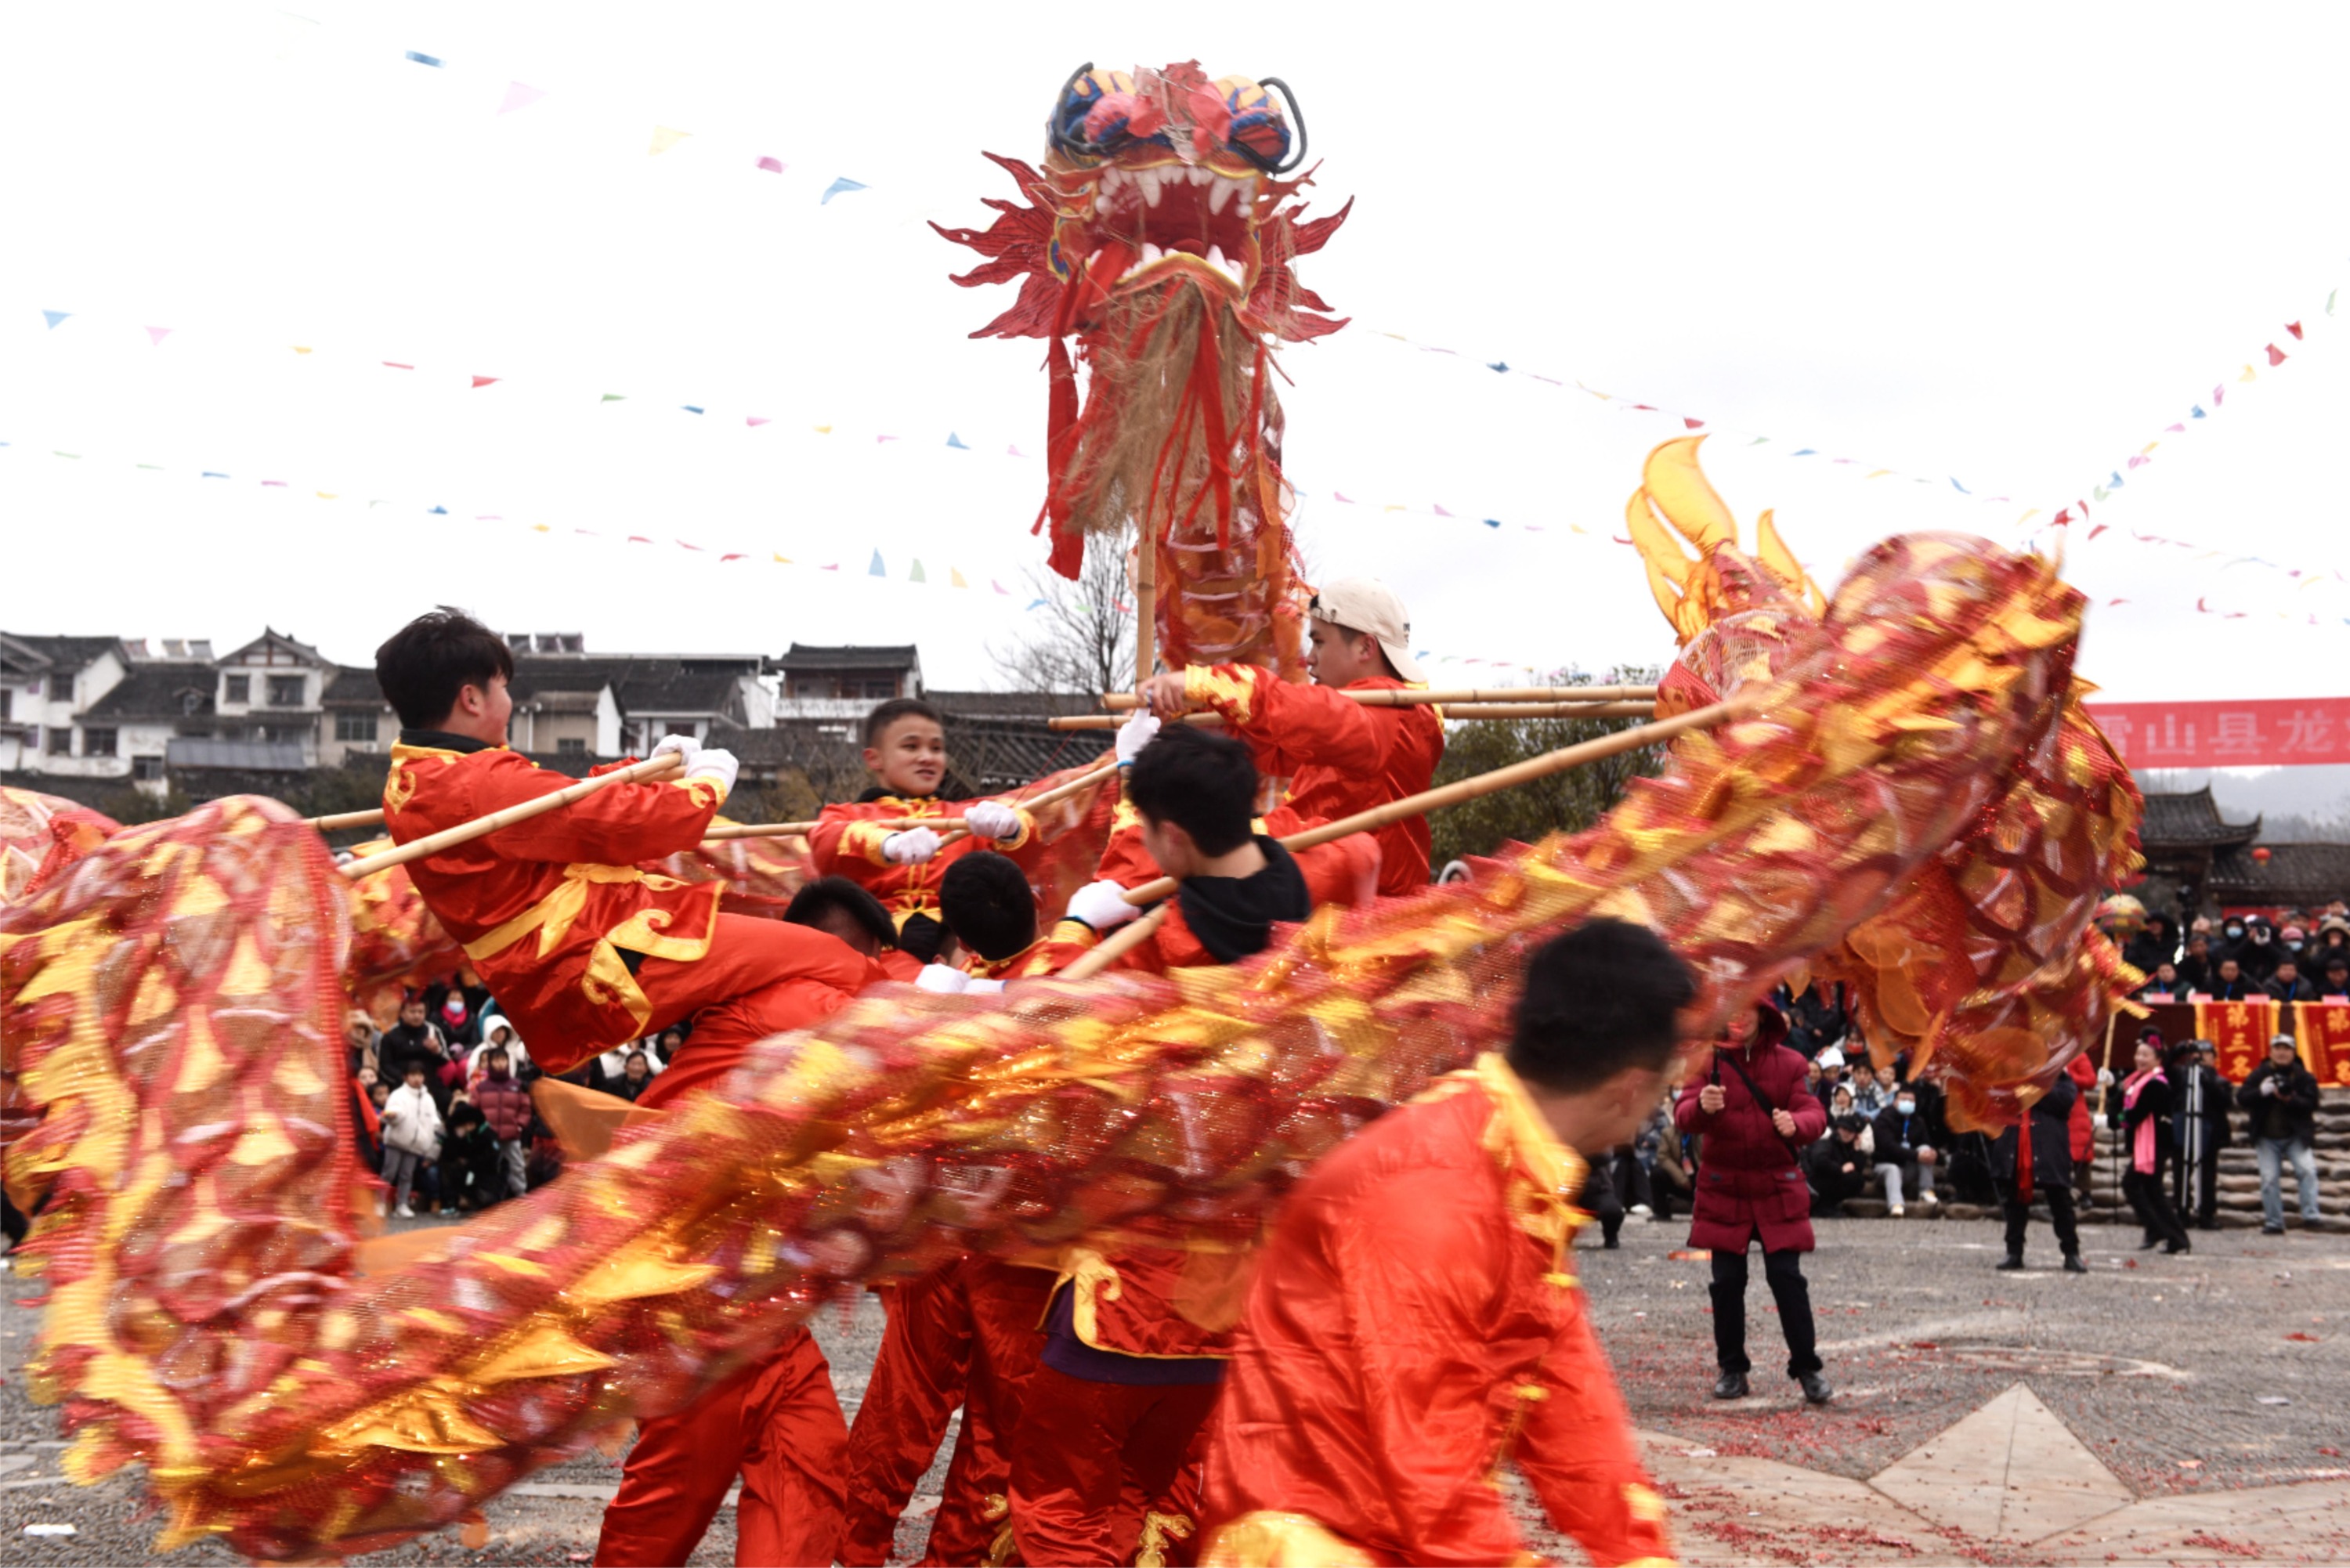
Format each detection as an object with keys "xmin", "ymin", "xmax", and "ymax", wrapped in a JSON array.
[{"xmin": 0, "ymin": 0, "xmax": 2350, "ymax": 700}]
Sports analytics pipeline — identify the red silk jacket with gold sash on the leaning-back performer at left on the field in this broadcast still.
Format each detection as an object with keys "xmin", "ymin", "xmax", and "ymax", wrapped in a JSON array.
[{"xmin": 383, "ymin": 740, "xmax": 726, "ymax": 1072}]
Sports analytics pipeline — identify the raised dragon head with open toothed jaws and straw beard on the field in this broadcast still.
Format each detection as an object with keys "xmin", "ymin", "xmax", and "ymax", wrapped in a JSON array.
[{"xmin": 933, "ymin": 61, "xmax": 1351, "ymax": 679}]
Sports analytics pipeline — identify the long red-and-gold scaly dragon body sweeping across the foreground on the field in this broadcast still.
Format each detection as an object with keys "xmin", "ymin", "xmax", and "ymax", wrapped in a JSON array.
[{"xmin": 0, "ymin": 503, "xmax": 2127, "ymax": 1561}]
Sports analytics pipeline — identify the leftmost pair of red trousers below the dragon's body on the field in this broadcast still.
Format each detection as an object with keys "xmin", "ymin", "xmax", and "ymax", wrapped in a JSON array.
[{"xmin": 595, "ymin": 1328, "xmax": 848, "ymax": 1568}]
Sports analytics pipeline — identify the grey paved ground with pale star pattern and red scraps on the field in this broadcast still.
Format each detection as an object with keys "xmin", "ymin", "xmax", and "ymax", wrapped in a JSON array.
[{"xmin": 0, "ymin": 1220, "xmax": 2350, "ymax": 1563}]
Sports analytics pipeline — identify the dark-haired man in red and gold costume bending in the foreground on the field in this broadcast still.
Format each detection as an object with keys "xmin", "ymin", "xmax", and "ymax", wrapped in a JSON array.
[{"xmin": 1201, "ymin": 919, "xmax": 1694, "ymax": 1568}]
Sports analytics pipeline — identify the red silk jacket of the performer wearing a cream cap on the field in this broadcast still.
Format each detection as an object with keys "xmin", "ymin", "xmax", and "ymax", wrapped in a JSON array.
[{"xmin": 1182, "ymin": 665, "xmax": 1445, "ymax": 898}]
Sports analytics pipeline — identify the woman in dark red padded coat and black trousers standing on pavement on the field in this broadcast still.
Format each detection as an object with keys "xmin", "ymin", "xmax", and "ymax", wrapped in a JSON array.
[{"xmin": 1673, "ymin": 1006, "xmax": 1833, "ymax": 1404}]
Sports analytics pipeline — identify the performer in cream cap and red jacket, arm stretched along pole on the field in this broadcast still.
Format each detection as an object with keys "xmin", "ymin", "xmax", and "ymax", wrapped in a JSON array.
[{"xmin": 1142, "ymin": 578, "xmax": 1445, "ymax": 898}]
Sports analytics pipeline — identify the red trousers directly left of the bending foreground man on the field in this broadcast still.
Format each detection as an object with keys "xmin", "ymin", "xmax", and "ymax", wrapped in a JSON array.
[{"xmin": 1010, "ymin": 1366, "xmax": 1217, "ymax": 1568}]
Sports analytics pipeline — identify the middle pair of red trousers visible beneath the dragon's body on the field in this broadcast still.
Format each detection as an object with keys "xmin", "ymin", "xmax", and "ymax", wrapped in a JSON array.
[{"xmin": 841, "ymin": 1258, "xmax": 1053, "ymax": 1568}]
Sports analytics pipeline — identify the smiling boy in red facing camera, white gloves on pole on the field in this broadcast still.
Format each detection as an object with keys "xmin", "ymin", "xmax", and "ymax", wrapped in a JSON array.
[{"xmin": 808, "ymin": 695, "xmax": 1036, "ymax": 962}]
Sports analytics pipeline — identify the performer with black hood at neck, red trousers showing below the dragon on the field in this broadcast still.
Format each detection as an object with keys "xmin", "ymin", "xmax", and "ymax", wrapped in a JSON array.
[{"xmin": 1010, "ymin": 724, "xmax": 1344, "ymax": 1563}]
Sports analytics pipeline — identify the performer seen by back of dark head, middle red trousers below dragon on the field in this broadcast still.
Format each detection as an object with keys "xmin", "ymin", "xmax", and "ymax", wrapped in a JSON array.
[{"xmin": 841, "ymin": 851, "xmax": 1083, "ymax": 1568}]
